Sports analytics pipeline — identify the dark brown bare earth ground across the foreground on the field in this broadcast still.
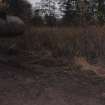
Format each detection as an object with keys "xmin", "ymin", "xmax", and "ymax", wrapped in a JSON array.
[{"xmin": 0, "ymin": 52, "xmax": 105, "ymax": 105}]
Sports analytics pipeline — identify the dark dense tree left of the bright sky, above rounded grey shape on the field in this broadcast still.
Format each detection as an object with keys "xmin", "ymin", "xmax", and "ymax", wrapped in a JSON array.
[{"xmin": 8, "ymin": 0, "xmax": 31, "ymax": 18}]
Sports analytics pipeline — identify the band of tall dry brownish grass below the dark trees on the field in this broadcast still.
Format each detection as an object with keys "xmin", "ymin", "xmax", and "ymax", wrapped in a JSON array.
[{"xmin": 18, "ymin": 26, "xmax": 105, "ymax": 63}]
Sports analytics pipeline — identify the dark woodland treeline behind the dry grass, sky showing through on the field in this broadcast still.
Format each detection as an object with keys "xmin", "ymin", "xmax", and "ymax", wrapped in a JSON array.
[{"xmin": 9, "ymin": 0, "xmax": 105, "ymax": 26}]
